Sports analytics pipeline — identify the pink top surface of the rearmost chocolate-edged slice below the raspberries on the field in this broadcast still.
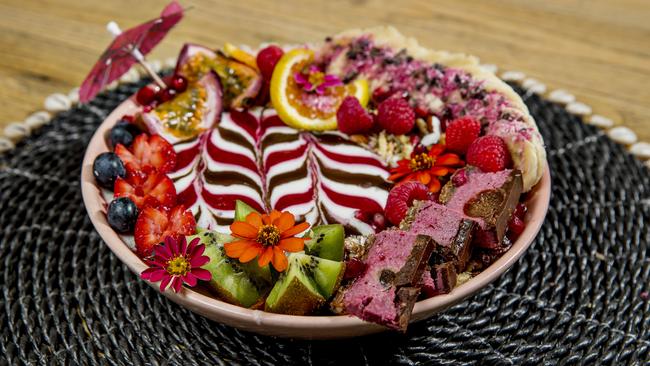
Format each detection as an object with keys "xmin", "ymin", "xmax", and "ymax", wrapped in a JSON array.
[{"xmin": 446, "ymin": 169, "xmax": 512, "ymax": 219}]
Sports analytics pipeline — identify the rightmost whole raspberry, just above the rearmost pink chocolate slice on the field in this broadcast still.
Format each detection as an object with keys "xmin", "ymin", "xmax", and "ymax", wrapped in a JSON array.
[{"xmin": 466, "ymin": 136, "xmax": 512, "ymax": 172}]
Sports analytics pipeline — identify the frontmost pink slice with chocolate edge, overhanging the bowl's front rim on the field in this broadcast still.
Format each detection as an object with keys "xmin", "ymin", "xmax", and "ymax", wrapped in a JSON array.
[{"xmin": 331, "ymin": 230, "xmax": 434, "ymax": 331}]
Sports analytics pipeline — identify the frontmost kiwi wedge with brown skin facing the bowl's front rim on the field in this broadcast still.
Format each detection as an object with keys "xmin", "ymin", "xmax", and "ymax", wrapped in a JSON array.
[{"xmin": 265, "ymin": 253, "xmax": 345, "ymax": 315}]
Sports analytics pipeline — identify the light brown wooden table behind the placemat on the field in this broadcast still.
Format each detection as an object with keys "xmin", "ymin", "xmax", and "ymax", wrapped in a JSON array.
[{"xmin": 0, "ymin": 0, "xmax": 650, "ymax": 141}]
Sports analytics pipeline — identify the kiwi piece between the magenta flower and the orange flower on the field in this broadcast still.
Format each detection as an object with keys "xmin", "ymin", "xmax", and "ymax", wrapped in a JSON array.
[{"xmin": 187, "ymin": 231, "xmax": 271, "ymax": 307}]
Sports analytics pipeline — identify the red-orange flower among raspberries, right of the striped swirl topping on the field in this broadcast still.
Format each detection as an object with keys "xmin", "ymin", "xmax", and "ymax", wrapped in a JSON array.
[{"xmin": 388, "ymin": 144, "xmax": 465, "ymax": 193}]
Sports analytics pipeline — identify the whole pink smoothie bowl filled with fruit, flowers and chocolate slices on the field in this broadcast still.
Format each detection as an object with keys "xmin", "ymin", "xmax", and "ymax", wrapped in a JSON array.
[{"xmin": 82, "ymin": 28, "xmax": 551, "ymax": 339}]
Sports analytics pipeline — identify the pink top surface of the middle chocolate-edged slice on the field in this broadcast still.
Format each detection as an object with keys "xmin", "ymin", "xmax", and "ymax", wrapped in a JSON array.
[{"xmin": 409, "ymin": 202, "xmax": 467, "ymax": 247}]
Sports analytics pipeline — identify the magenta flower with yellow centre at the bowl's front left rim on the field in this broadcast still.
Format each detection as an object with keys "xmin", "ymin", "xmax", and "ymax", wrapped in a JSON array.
[{"xmin": 140, "ymin": 236, "xmax": 212, "ymax": 293}]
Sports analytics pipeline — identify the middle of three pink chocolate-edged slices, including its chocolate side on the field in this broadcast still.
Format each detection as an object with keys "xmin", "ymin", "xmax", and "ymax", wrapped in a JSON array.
[{"xmin": 401, "ymin": 202, "xmax": 475, "ymax": 272}]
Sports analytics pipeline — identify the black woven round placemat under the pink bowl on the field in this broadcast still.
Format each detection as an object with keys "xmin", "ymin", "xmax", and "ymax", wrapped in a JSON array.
[{"xmin": 0, "ymin": 78, "xmax": 650, "ymax": 365}]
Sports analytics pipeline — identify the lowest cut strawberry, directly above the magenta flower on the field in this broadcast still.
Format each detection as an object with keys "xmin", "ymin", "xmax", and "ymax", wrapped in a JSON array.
[{"xmin": 135, "ymin": 205, "xmax": 196, "ymax": 257}]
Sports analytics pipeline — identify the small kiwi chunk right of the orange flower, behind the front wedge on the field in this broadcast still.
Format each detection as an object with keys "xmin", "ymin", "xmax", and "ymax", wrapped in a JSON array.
[{"xmin": 305, "ymin": 224, "xmax": 345, "ymax": 261}]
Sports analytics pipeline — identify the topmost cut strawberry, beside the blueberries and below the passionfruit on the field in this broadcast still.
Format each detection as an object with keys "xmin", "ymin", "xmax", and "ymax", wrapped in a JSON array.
[{"xmin": 115, "ymin": 133, "xmax": 176, "ymax": 173}]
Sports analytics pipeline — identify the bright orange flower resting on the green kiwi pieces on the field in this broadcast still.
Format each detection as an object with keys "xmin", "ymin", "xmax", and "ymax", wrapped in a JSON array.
[{"xmin": 224, "ymin": 210, "xmax": 309, "ymax": 272}]
